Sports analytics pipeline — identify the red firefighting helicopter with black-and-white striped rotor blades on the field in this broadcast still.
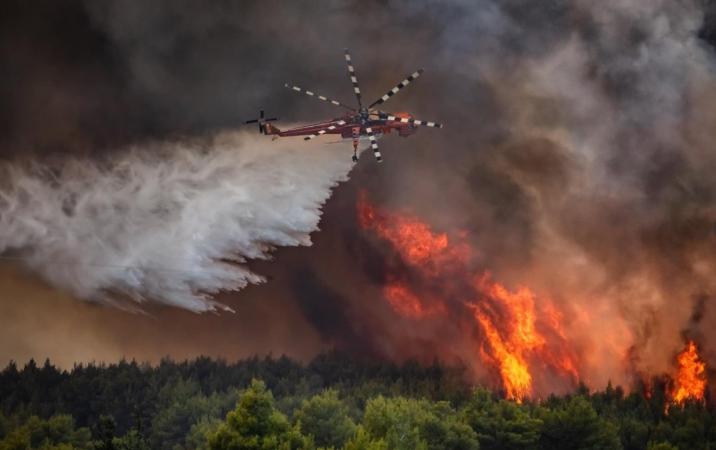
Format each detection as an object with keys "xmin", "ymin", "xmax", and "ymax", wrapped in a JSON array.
[{"xmin": 245, "ymin": 49, "xmax": 443, "ymax": 162}]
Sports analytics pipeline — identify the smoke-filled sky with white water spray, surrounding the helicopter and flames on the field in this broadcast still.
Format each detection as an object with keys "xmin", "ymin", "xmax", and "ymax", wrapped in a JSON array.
[{"xmin": 0, "ymin": 0, "xmax": 716, "ymax": 394}]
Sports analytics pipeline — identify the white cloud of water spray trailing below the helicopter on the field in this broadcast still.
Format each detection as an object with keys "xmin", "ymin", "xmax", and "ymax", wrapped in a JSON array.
[{"xmin": 0, "ymin": 132, "xmax": 350, "ymax": 312}]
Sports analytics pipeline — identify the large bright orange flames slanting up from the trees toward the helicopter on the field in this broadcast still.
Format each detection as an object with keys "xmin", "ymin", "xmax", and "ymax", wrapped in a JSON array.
[{"xmin": 358, "ymin": 193, "xmax": 579, "ymax": 401}]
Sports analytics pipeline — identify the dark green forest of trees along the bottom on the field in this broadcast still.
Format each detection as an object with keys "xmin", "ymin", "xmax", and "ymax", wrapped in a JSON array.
[{"xmin": 0, "ymin": 353, "xmax": 716, "ymax": 450}]
